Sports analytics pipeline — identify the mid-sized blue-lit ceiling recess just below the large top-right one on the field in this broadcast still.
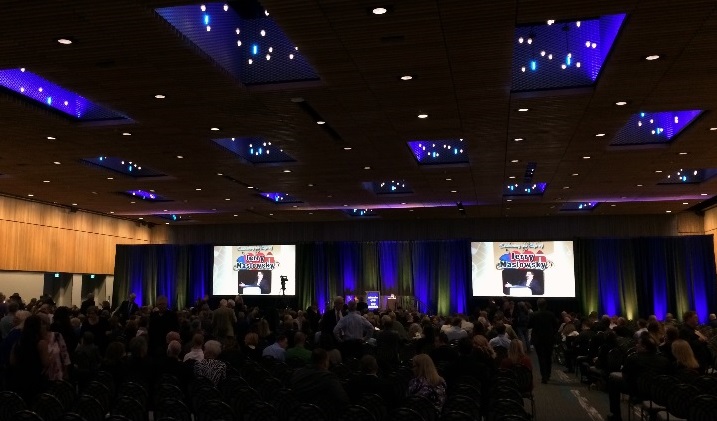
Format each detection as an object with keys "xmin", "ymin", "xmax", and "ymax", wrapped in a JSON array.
[{"xmin": 610, "ymin": 110, "xmax": 702, "ymax": 146}]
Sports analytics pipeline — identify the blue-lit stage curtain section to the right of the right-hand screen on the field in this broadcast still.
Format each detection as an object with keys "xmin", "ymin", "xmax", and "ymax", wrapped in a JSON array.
[{"xmin": 575, "ymin": 235, "xmax": 717, "ymax": 322}]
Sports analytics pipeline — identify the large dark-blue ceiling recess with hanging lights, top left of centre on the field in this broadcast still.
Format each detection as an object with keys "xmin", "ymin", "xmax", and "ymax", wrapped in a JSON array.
[{"xmin": 156, "ymin": 3, "xmax": 319, "ymax": 85}]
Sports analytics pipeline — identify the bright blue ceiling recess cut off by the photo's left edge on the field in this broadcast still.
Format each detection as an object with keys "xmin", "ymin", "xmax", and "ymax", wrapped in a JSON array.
[{"xmin": 0, "ymin": 68, "xmax": 129, "ymax": 122}]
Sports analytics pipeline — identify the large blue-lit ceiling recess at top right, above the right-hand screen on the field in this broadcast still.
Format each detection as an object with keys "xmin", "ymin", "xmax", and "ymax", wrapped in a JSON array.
[{"xmin": 511, "ymin": 14, "xmax": 626, "ymax": 92}]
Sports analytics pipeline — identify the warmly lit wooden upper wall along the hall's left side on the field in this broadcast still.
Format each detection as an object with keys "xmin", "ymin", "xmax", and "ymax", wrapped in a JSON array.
[{"xmin": 0, "ymin": 197, "xmax": 168, "ymax": 274}]
